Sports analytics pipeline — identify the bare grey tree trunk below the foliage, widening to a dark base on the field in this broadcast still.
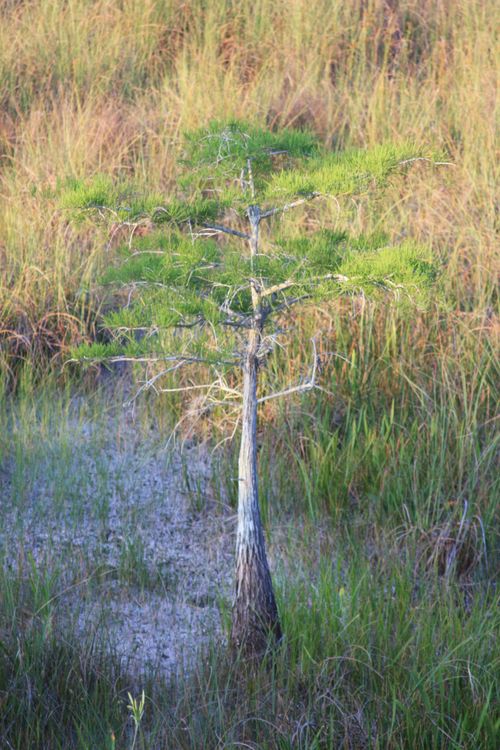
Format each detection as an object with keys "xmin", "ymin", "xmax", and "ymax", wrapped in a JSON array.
[{"xmin": 231, "ymin": 328, "xmax": 281, "ymax": 655}]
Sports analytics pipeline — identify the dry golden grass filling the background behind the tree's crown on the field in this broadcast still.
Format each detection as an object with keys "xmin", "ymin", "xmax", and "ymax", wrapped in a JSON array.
[{"xmin": 0, "ymin": 0, "xmax": 497, "ymax": 374}]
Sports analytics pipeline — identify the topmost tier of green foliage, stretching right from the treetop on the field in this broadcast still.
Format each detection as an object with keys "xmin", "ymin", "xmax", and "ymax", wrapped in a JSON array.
[{"xmin": 183, "ymin": 122, "xmax": 421, "ymax": 208}]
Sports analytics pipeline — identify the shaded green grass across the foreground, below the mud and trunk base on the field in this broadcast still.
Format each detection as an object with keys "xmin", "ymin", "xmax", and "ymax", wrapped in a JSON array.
[{"xmin": 0, "ymin": 526, "xmax": 499, "ymax": 750}]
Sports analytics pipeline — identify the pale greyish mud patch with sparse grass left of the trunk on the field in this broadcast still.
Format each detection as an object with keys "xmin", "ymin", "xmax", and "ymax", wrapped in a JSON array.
[{"xmin": 0, "ymin": 408, "xmax": 234, "ymax": 674}]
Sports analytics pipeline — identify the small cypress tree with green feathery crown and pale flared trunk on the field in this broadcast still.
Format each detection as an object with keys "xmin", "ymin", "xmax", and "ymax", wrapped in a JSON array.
[{"xmin": 64, "ymin": 122, "xmax": 433, "ymax": 654}]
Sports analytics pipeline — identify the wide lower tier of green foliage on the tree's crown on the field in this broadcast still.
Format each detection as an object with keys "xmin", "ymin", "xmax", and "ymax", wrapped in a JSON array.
[{"xmin": 75, "ymin": 231, "xmax": 435, "ymax": 368}]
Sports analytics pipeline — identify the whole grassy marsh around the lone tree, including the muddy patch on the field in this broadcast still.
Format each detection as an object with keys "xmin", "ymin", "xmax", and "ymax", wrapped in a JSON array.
[{"xmin": 0, "ymin": 0, "xmax": 499, "ymax": 750}]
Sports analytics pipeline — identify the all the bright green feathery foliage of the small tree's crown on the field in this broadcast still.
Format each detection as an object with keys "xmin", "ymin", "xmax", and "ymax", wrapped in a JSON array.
[{"xmin": 67, "ymin": 122, "xmax": 435, "ymax": 359}]
